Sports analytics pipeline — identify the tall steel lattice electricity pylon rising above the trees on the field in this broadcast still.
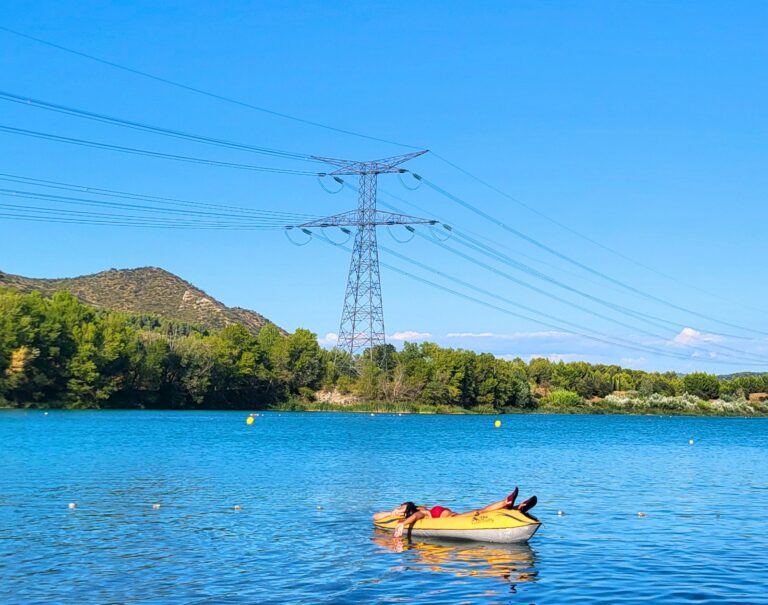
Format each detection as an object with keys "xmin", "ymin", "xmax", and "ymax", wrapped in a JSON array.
[{"xmin": 297, "ymin": 151, "xmax": 437, "ymax": 366}]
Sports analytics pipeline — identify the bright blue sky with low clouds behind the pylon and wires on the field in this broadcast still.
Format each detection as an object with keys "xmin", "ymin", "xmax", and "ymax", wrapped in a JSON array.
[{"xmin": 0, "ymin": 0, "xmax": 768, "ymax": 372}]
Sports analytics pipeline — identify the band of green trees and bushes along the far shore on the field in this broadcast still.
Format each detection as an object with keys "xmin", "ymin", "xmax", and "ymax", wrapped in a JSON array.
[{"xmin": 0, "ymin": 289, "xmax": 768, "ymax": 416}]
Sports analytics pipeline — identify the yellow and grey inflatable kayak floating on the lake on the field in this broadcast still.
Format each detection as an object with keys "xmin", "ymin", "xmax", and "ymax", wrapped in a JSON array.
[{"xmin": 373, "ymin": 510, "xmax": 541, "ymax": 544}]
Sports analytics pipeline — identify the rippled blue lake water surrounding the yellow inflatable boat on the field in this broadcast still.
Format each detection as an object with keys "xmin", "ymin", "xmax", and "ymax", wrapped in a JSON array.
[{"xmin": 0, "ymin": 411, "xmax": 768, "ymax": 604}]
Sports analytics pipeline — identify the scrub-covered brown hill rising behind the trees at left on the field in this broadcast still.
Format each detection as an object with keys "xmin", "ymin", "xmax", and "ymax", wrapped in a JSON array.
[{"xmin": 0, "ymin": 267, "xmax": 280, "ymax": 334}]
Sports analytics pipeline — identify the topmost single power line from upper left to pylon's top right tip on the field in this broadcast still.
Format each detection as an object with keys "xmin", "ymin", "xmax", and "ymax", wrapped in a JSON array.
[{"xmin": 0, "ymin": 26, "xmax": 423, "ymax": 149}]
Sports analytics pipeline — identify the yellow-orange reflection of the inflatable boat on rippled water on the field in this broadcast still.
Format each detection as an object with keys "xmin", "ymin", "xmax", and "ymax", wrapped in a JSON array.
[{"xmin": 371, "ymin": 529, "xmax": 538, "ymax": 592}]
